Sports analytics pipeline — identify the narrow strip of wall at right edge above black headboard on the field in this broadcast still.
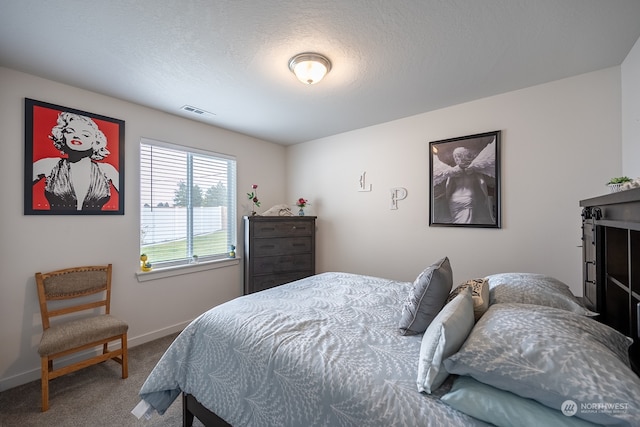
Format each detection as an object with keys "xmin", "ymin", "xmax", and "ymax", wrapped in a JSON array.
[{"xmin": 621, "ymin": 34, "xmax": 640, "ymax": 179}]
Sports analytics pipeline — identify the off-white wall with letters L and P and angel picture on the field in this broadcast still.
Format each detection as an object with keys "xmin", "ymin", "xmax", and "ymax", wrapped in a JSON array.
[{"xmin": 287, "ymin": 67, "xmax": 621, "ymax": 295}]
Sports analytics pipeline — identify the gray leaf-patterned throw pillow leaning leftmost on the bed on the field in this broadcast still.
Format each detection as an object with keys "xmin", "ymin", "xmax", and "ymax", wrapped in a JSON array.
[{"xmin": 399, "ymin": 257, "xmax": 453, "ymax": 335}]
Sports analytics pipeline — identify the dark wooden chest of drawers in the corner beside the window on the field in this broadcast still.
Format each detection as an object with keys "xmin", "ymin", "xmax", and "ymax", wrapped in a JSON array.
[{"xmin": 244, "ymin": 216, "xmax": 316, "ymax": 294}]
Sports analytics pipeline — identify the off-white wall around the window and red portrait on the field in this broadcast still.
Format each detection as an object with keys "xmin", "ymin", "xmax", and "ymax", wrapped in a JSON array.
[{"xmin": 0, "ymin": 68, "xmax": 285, "ymax": 390}]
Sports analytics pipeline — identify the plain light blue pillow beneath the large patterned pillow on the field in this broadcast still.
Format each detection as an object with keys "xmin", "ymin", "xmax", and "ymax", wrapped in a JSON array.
[{"xmin": 440, "ymin": 376, "xmax": 597, "ymax": 427}]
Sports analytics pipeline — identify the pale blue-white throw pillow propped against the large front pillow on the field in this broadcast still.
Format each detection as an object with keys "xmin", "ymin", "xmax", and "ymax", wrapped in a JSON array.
[{"xmin": 417, "ymin": 288, "xmax": 475, "ymax": 394}]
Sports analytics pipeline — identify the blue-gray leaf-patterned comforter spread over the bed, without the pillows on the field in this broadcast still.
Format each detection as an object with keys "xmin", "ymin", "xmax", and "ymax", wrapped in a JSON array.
[{"xmin": 140, "ymin": 273, "xmax": 484, "ymax": 427}]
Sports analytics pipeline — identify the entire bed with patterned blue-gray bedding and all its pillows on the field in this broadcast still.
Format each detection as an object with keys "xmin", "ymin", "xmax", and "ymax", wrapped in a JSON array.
[{"xmin": 134, "ymin": 258, "xmax": 640, "ymax": 427}]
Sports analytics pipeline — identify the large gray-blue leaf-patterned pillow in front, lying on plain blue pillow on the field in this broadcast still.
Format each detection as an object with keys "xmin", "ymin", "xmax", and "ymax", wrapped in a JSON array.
[{"xmin": 444, "ymin": 303, "xmax": 640, "ymax": 425}]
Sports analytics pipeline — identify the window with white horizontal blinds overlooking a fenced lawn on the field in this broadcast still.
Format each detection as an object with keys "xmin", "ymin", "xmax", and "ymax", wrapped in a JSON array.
[{"xmin": 140, "ymin": 138, "xmax": 236, "ymax": 268}]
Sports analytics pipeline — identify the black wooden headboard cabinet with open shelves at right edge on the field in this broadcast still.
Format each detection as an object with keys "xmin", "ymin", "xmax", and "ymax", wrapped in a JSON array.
[{"xmin": 580, "ymin": 188, "xmax": 640, "ymax": 373}]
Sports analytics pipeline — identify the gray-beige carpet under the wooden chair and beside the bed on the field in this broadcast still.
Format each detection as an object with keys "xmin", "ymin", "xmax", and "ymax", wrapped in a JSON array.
[{"xmin": 0, "ymin": 334, "xmax": 202, "ymax": 427}]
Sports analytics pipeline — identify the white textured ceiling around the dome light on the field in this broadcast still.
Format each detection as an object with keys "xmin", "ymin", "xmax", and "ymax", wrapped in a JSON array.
[{"xmin": 0, "ymin": 0, "xmax": 640, "ymax": 145}]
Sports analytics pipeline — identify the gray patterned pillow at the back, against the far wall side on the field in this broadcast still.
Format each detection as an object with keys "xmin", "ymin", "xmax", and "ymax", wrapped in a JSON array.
[{"xmin": 485, "ymin": 273, "xmax": 598, "ymax": 316}]
